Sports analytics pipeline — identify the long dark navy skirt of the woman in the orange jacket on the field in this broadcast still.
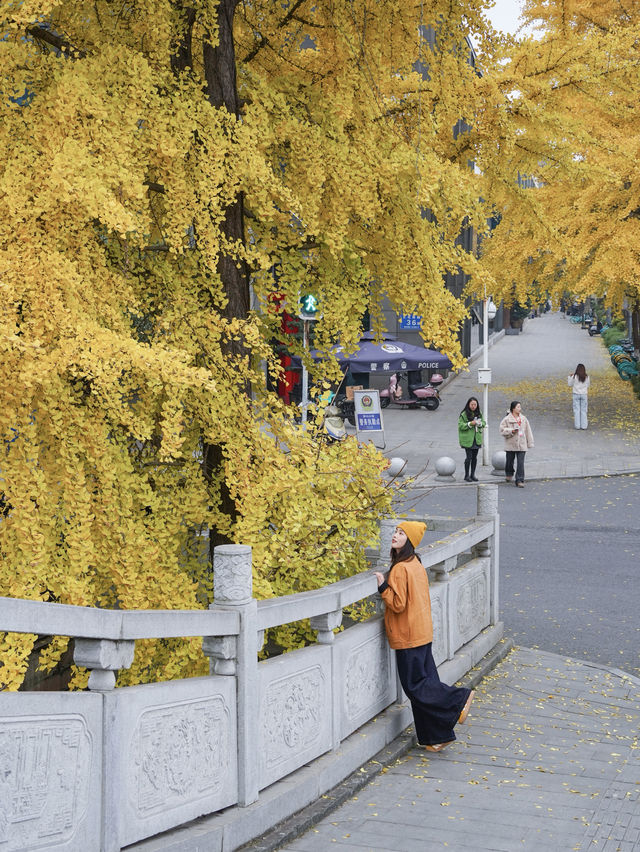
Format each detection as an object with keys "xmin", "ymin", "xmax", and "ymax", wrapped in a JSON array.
[{"xmin": 396, "ymin": 642, "xmax": 471, "ymax": 745}]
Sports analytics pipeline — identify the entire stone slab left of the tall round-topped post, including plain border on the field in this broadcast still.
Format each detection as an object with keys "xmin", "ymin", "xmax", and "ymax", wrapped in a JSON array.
[{"xmin": 119, "ymin": 675, "xmax": 238, "ymax": 852}]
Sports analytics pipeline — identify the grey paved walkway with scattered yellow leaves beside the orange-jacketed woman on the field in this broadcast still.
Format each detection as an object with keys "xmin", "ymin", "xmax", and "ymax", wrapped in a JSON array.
[{"xmin": 282, "ymin": 649, "xmax": 640, "ymax": 852}]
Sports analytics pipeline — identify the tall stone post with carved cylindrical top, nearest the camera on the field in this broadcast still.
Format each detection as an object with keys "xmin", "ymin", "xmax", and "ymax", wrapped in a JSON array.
[{"xmin": 203, "ymin": 544, "xmax": 262, "ymax": 807}]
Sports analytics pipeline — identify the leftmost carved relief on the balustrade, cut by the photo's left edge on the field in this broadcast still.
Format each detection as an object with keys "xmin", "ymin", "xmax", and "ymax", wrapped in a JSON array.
[{"xmin": 0, "ymin": 714, "xmax": 93, "ymax": 852}]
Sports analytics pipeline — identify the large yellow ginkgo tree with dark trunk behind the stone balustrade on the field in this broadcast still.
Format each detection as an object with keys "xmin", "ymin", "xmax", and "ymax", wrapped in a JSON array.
[{"xmin": 0, "ymin": 0, "xmax": 510, "ymax": 688}]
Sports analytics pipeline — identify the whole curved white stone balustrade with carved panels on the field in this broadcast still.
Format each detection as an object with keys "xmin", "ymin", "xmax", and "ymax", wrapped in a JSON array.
[{"xmin": 0, "ymin": 485, "xmax": 502, "ymax": 852}]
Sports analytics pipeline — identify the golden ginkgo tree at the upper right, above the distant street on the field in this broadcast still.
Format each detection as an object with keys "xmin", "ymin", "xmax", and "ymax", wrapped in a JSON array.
[{"xmin": 476, "ymin": 0, "xmax": 640, "ymax": 332}]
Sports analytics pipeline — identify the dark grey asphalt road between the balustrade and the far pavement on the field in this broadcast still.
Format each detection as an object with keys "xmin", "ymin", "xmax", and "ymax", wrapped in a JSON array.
[{"xmin": 400, "ymin": 475, "xmax": 640, "ymax": 675}]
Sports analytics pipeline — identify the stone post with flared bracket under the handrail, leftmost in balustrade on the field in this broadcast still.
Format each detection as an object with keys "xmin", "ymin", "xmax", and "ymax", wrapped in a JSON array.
[{"xmin": 73, "ymin": 639, "xmax": 135, "ymax": 852}]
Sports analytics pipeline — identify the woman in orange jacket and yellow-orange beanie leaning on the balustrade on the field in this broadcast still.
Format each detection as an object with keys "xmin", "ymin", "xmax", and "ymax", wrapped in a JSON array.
[{"xmin": 375, "ymin": 521, "xmax": 473, "ymax": 752}]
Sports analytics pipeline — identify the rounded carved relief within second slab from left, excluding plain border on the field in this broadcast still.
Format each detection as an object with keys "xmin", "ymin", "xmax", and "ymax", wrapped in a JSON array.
[{"xmin": 131, "ymin": 696, "xmax": 230, "ymax": 818}]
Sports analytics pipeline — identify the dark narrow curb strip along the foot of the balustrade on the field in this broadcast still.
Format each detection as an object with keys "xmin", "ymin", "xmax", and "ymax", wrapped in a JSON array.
[{"xmin": 237, "ymin": 639, "xmax": 515, "ymax": 852}]
